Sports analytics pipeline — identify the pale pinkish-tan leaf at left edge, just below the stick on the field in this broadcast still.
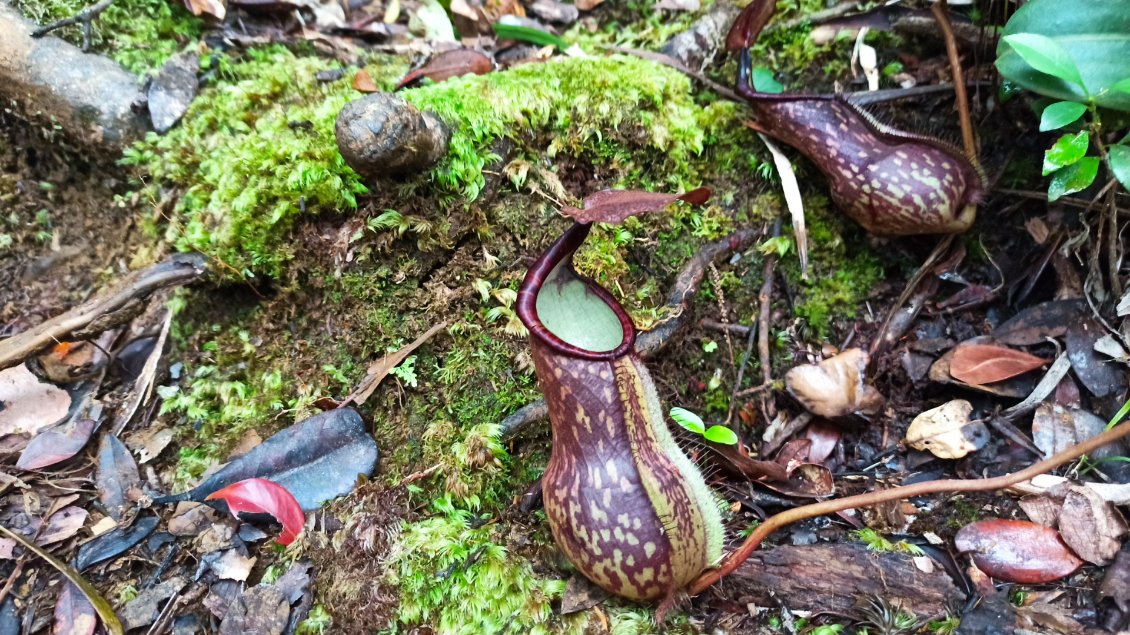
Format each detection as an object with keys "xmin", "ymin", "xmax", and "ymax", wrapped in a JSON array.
[{"xmin": 0, "ymin": 364, "xmax": 71, "ymax": 436}]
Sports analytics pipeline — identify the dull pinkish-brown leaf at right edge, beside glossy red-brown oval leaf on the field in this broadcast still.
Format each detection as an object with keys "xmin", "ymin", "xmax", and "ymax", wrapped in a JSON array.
[{"xmin": 1059, "ymin": 486, "xmax": 1127, "ymax": 566}]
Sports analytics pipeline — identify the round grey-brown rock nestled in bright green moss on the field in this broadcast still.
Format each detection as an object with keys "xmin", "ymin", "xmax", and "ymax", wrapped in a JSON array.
[{"xmin": 333, "ymin": 93, "xmax": 451, "ymax": 179}]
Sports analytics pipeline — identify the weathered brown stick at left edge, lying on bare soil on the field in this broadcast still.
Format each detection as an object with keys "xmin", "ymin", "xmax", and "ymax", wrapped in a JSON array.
[{"xmin": 0, "ymin": 253, "xmax": 207, "ymax": 371}]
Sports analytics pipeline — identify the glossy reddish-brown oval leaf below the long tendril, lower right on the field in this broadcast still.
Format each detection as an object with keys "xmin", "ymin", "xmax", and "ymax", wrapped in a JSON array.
[{"xmin": 954, "ymin": 519, "xmax": 1083, "ymax": 584}]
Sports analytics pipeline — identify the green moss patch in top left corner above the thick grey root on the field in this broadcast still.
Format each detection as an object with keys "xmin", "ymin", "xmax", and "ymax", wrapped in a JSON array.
[{"xmin": 14, "ymin": 0, "xmax": 203, "ymax": 75}]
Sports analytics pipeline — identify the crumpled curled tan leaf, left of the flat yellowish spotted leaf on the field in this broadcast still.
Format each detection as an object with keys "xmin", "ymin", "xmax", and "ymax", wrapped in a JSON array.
[{"xmin": 784, "ymin": 348, "xmax": 886, "ymax": 419}]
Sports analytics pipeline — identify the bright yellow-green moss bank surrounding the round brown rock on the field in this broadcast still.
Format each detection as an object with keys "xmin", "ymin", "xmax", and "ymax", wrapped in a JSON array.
[{"xmin": 123, "ymin": 46, "xmax": 750, "ymax": 277}]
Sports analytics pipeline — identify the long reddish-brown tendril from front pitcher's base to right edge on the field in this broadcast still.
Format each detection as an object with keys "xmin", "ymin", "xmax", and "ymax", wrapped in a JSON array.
[{"xmin": 687, "ymin": 415, "xmax": 1130, "ymax": 595}]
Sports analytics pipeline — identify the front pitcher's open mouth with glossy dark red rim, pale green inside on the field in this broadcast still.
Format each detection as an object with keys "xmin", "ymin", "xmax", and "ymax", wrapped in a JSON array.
[{"xmin": 518, "ymin": 223, "xmax": 636, "ymax": 359}]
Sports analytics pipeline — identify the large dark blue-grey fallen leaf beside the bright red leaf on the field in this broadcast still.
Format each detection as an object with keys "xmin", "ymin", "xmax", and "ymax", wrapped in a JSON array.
[{"xmin": 154, "ymin": 408, "xmax": 379, "ymax": 512}]
